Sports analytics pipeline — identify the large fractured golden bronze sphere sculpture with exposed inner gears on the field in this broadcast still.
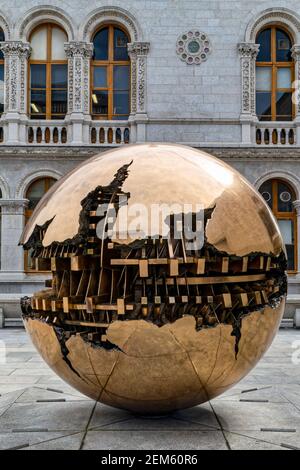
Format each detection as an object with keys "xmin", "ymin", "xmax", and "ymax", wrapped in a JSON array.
[{"xmin": 21, "ymin": 144, "xmax": 286, "ymax": 414}]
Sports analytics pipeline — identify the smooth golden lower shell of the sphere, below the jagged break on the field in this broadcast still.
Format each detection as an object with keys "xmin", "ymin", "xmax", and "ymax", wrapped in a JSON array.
[{"xmin": 25, "ymin": 300, "xmax": 285, "ymax": 414}]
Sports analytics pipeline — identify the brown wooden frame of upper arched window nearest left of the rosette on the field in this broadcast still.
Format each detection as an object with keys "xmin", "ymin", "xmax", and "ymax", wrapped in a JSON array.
[{"xmin": 90, "ymin": 23, "xmax": 131, "ymax": 122}]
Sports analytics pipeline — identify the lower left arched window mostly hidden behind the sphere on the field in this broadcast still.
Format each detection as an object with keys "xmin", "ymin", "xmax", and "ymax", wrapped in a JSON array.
[{"xmin": 24, "ymin": 178, "xmax": 56, "ymax": 271}]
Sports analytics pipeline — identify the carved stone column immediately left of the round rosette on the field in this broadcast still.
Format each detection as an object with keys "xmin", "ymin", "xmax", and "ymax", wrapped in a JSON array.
[{"xmin": 128, "ymin": 42, "xmax": 150, "ymax": 142}]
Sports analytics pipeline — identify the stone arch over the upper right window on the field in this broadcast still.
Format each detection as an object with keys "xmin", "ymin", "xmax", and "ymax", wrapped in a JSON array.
[{"xmin": 245, "ymin": 7, "xmax": 300, "ymax": 43}]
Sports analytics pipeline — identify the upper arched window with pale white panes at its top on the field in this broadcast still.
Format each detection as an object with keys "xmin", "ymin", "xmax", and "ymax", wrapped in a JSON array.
[{"xmin": 29, "ymin": 24, "xmax": 68, "ymax": 119}]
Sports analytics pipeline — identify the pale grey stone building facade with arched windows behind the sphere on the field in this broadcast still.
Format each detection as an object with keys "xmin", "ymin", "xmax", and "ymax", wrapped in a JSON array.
[{"xmin": 0, "ymin": 0, "xmax": 300, "ymax": 326}]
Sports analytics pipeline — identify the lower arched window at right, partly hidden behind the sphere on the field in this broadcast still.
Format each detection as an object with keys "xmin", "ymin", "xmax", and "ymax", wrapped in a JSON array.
[{"xmin": 259, "ymin": 179, "xmax": 297, "ymax": 271}]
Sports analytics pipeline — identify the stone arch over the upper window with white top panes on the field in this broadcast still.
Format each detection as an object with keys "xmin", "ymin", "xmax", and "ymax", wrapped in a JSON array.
[{"xmin": 16, "ymin": 5, "xmax": 74, "ymax": 42}]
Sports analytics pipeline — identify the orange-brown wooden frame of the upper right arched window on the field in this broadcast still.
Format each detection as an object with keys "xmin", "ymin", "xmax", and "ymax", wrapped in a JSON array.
[{"xmin": 255, "ymin": 24, "xmax": 296, "ymax": 122}]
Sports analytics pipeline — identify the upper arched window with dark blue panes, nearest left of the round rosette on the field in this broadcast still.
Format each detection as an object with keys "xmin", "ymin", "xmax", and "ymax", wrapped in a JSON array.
[{"xmin": 91, "ymin": 25, "xmax": 130, "ymax": 119}]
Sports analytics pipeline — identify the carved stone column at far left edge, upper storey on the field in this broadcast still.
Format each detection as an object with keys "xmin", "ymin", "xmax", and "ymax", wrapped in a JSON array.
[{"xmin": 1, "ymin": 41, "xmax": 31, "ymax": 145}]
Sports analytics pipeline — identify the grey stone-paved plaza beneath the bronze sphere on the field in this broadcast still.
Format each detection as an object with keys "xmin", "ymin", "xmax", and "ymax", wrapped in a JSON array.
[{"xmin": 0, "ymin": 328, "xmax": 300, "ymax": 450}]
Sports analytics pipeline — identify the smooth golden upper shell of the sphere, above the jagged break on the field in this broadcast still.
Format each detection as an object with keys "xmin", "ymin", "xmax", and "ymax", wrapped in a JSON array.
[{"xmin": 21, "ymin": 144, "xmax": 282, "ymax": 256}]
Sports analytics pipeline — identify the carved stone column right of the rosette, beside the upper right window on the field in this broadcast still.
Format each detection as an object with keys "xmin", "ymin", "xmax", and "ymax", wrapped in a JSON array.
[{"xmin": 238, "ymin": 42, "xmax": 259, "ymax": 144}]
